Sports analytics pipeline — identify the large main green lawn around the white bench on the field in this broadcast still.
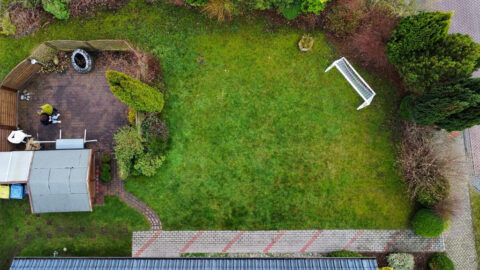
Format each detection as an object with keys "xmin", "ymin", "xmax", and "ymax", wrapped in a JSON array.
[{"xmin": 0, "ymin": 2, "xmax": 413, "ymax": 233}]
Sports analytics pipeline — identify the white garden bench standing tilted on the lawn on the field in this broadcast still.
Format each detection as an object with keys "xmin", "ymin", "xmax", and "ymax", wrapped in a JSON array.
[{"xmin": 325, "ymin": 57, "xmax": 376, "ymax": 110}]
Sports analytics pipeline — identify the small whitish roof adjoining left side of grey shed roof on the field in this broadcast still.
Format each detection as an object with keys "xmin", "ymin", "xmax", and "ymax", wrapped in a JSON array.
[{"xmin": 0, "ymin": 151, "xmax": 33, "ymax": 184}]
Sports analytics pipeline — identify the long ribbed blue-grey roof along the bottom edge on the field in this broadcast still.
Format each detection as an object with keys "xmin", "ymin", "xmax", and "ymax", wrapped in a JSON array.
[{"xmin": 10, "ymin": 258, "xmax": 378, "ymax": 270}]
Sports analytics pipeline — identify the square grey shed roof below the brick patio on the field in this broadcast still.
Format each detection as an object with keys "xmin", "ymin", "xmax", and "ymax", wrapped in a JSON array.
[{"xmin": 28, "ymin": 149, "xmax": 91, "ymax": 213}]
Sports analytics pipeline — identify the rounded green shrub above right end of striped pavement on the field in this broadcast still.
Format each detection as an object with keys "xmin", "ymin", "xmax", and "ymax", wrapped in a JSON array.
[{"xmin": 410, "ymin": 209, "xmax": 447, "ymax": 236}]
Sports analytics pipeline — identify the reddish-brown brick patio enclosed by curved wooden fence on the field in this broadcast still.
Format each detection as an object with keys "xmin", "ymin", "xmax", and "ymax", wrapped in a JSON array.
[{"xmin": 18, "ymin": 53, "xmax": 132, "ymax": 152}]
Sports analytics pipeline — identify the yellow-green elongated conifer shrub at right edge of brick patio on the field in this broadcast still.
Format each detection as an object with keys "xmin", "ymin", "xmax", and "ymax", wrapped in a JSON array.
[{"xmin": 106, "ymin": 70, "xmax": 164, "ymax": 112}]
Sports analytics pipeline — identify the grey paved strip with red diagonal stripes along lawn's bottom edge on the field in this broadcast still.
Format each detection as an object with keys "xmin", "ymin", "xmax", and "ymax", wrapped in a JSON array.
[{"xmin": 132, "ymin": 230, "xmax": 445, "ymax": 257}]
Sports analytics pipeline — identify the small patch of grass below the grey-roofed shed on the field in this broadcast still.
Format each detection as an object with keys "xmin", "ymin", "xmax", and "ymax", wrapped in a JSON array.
[{"xmin": 0, "ymin": 197, "xmax": 149, "ymax": 269}]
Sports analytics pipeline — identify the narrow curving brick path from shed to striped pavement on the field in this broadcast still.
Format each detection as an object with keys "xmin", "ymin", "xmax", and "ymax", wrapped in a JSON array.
[{"xmin": 105, "ymin": 161, "xmax": 162, "ymax": 230}]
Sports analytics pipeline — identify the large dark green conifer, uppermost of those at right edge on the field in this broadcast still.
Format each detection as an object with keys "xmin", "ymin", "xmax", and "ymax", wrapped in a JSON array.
[{"xmin": 388, "ymin": 12, "xmax": 480, "ymax": 94}]
